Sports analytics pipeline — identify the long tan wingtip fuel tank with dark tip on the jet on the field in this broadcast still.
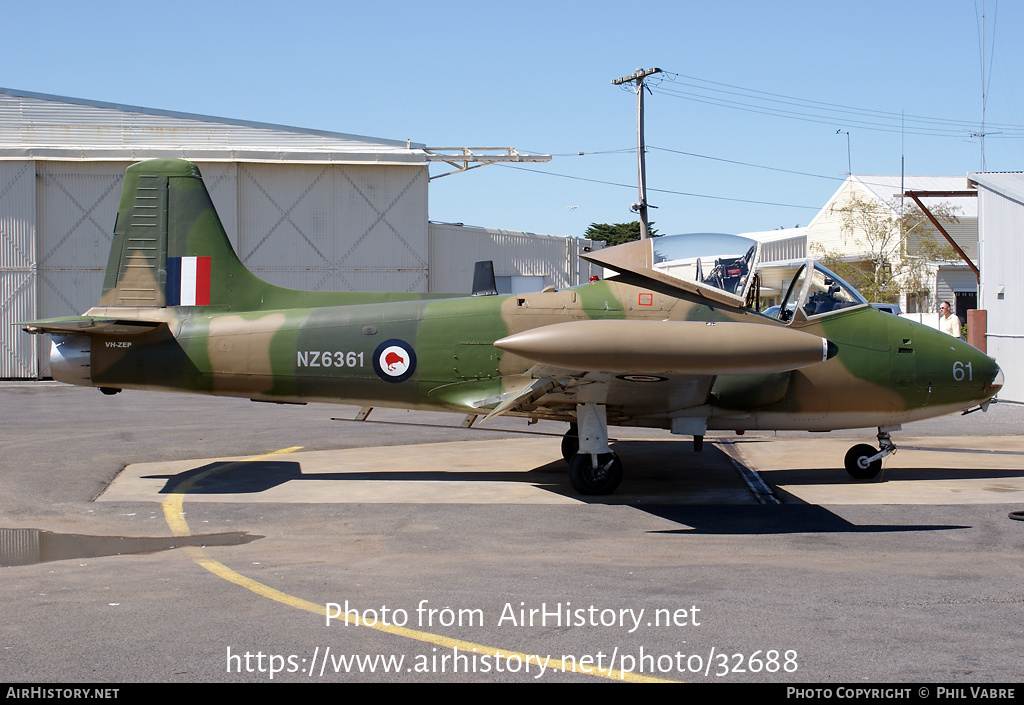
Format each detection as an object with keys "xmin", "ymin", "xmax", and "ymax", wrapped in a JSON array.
[{"xmin": 495, "ymin": 320, "xmax": 838, "ymax": 375}]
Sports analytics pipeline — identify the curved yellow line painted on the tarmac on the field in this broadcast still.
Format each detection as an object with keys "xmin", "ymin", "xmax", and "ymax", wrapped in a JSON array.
[{"xmin": 161, "ymin": 446, "xmax": 673, "ymax": 682}]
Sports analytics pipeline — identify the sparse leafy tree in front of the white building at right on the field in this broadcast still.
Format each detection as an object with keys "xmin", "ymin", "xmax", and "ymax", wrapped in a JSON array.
[{"xmin": 812, "ymin": 196, "xmax": 959, "ymax": 303}]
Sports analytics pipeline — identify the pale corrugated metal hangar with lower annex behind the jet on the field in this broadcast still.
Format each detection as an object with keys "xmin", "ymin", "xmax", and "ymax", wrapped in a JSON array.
[{"xmin": 0, "ymin": 88, "xmax": 602, "ymax": 379}]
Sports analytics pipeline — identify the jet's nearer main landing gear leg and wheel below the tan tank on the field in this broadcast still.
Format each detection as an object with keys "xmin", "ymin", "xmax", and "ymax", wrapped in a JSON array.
[{"xmin": 562, "ymin": 404, "xmax": 623, "ymax": 495}]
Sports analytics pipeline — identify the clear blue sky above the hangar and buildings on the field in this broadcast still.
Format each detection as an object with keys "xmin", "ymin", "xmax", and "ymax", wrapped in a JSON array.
[{"xmin": 0, "ymin": 0, "xmax": 1024, "ymax": 235}]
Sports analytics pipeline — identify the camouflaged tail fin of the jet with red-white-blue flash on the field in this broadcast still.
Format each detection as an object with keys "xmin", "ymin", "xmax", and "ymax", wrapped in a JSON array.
[{"xmin": 99, "ymin": 159, "xmax": 260, "ymax": 309}]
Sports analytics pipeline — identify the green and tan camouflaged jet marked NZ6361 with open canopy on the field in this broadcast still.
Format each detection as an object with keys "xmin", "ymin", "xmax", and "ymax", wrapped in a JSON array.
[{"xmin": 22, "ymin": 160, "xmax": 1002, "ymax": 494}]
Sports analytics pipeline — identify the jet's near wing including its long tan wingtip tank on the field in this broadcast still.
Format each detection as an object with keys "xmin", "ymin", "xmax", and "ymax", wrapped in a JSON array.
[{"xmin": 481, "ymin": 320, "xmax": 838, "ymax": 420}]
